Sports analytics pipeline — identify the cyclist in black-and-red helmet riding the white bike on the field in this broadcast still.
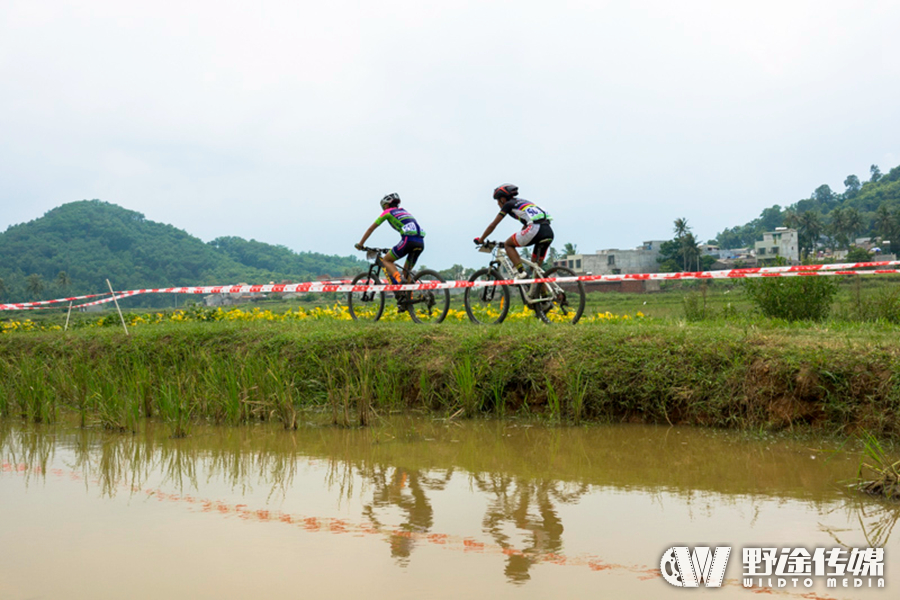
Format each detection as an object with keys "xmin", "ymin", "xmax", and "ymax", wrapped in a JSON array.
[{"xmin": 475, "ymin": 183, "xmax": 553, "ymax": 279}]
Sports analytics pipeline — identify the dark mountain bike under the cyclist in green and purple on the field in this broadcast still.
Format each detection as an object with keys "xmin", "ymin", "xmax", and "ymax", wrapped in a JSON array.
[{"xmin": 347, "ymin": 248, "xmax": 450, "ymax": 323}]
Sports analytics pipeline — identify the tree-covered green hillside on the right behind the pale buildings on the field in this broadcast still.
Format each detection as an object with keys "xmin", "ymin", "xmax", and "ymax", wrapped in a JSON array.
[{"xmin": 715, "ymin": 165, "xmax": 900, "ymax": 249}]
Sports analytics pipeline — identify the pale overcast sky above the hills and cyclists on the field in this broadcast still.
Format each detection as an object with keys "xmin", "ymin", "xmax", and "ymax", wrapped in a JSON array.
[{"xmin": 0, "ymin": 0, "xmax": 900, "ymax": 268}]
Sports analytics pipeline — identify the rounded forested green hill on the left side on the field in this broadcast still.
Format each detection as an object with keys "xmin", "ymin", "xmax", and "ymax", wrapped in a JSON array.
[{"xmin": 0, "ymin": 200, "xmax": 365, "ymax": 301}]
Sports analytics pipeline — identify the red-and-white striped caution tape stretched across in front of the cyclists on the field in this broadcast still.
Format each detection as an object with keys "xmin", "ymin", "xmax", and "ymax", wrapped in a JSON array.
[{"xmin": 0, "ymin": 261, "xmax": 900, "ymax": 311}]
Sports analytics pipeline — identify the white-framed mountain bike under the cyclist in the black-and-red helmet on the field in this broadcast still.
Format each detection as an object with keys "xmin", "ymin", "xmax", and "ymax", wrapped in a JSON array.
[{"xmin": 464, "ymin": 240, "xmax": 585, "ymax": 325}]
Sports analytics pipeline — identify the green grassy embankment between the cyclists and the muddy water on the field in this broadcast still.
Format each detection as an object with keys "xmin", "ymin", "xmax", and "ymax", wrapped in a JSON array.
[{"xmin": 0, "ymin": 320, "xmax": 900, "ymax": 436}]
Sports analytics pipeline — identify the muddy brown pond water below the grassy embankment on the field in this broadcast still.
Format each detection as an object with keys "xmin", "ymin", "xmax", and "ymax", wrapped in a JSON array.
[{"xmin": 0, "ymin": 419, "xmax": 900, "ymax": 600}]
